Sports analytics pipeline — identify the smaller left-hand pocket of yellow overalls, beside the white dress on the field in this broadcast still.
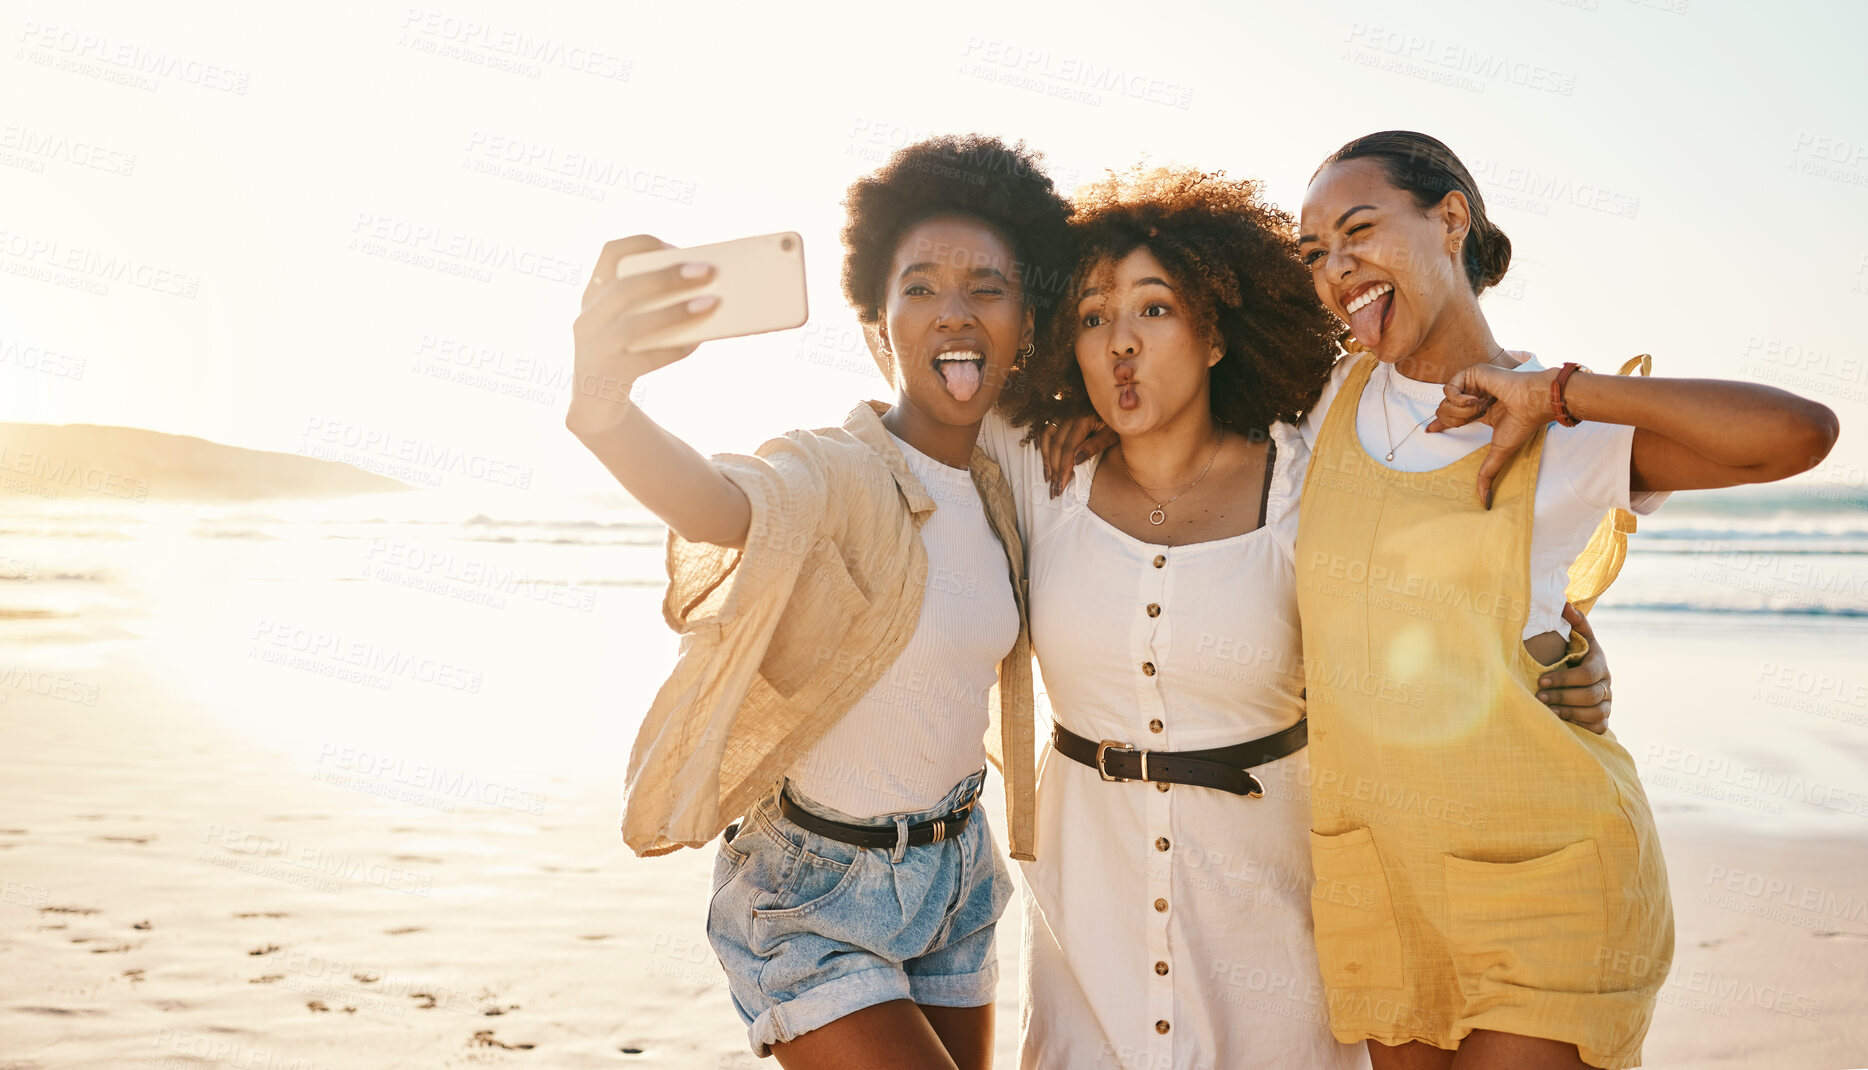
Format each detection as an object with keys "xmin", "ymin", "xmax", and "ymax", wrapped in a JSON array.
[{"xmin": 1309, "ymin": 827, "xmax": 1403, "ymax": 988}]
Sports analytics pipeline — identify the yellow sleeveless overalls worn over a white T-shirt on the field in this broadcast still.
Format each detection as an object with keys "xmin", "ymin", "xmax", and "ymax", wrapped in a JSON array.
[{"xmin": 1296, "ymin": 357, "xmax": 1674, "ymax": 1068}]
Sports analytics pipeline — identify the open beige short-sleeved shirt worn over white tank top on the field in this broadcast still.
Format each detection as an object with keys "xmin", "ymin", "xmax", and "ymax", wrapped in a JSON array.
[{"xmin": 622, "ymin": 401, "xmax": 1037, "ymax": 861}]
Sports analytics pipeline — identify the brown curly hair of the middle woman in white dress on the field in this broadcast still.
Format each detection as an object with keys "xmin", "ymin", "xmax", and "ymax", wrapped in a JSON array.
[{"xmin": 1007, "ymin": 166, "xmax": 1343, "ymax": 437}]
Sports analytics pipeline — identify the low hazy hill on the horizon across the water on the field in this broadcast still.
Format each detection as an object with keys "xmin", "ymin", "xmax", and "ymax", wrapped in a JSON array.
[{"xmin": 0, "ymin": 424, "xmax": 413, "ymax": 500}]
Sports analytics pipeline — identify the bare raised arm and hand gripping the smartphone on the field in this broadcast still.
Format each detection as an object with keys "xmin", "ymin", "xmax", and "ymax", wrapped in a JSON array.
[{"xmin": 564, "ymin": 235, "xmax": 753, "ymax": 549}]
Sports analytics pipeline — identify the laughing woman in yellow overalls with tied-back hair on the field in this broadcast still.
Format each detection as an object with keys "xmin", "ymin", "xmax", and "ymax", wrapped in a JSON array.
[{"xmin": 1296, "ymin": 131, "xmax": 1836, "ymax": 1070}]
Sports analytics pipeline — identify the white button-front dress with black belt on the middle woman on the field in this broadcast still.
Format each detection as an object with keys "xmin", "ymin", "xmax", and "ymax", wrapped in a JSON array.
[{"xmin": 981, "ymin": 416, "xmax": 1367, "ymax": 1070}]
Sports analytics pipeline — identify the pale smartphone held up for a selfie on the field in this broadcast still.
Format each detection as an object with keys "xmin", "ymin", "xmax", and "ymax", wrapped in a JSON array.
[{"xmin": 616, "ymin": 232, "xmax": 811, "ymax": 349}]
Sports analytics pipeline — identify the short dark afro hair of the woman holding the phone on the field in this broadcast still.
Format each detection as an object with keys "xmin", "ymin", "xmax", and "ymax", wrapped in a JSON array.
[{"xmin": 842, "ymin": 134, "xmax": 1070, "ymax": 332}]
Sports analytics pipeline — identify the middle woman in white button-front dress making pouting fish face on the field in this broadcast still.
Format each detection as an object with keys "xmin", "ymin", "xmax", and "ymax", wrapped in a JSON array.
[{"xmin": 981, "ymin": 172, "xmax": 1603, "ymax": 1070}]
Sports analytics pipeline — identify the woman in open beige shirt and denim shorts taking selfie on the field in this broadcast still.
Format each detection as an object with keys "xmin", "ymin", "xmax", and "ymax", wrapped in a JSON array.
[{"xmin": 566, "ymin": 136, "xmax": 1068, "ymax": 1070}]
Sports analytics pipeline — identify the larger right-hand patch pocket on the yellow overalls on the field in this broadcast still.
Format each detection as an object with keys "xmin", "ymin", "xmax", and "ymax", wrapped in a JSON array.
[{"xmin": 1442, "ymin": 840, "xmax": 1614, "ymax": 999}]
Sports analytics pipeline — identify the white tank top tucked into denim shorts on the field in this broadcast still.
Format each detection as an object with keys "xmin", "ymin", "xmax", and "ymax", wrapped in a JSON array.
[{"xmin": 785, "ymin": 435, "xmax": 1018, "ymax": 818}]
